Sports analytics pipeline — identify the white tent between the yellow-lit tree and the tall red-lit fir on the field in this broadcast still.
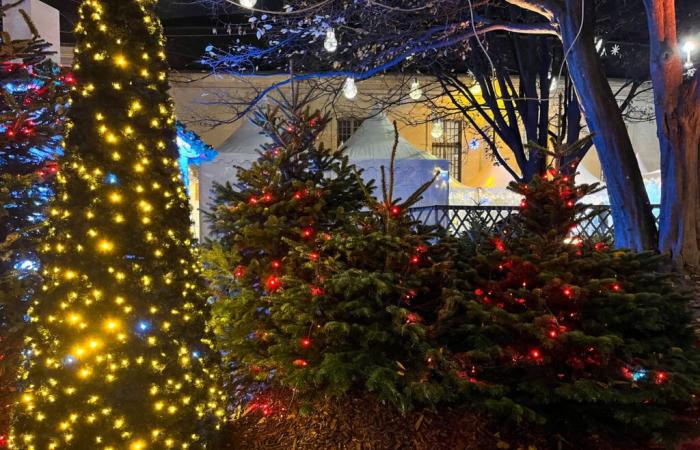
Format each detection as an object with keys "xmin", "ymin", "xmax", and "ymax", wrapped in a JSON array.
[{"xmin": 199, "ymin": 119, "xmax": 271, "ymax": 236}]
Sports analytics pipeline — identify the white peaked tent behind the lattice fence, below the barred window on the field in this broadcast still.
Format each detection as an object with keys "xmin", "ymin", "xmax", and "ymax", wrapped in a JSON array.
[{"xmin": 344, "ymin": 113, "xmax": 450, "ymax": 206}]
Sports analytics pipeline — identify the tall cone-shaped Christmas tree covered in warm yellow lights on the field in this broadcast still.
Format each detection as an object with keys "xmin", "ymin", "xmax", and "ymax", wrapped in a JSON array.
[{"xmin": 11, "ymin": 0, "xmax": 223, "ymax": 450}]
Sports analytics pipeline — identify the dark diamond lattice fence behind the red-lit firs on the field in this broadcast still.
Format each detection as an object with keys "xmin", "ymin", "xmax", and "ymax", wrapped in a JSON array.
[{"xmin": 410, "ymin": 205, "xmax": 659, "ymax": 240}]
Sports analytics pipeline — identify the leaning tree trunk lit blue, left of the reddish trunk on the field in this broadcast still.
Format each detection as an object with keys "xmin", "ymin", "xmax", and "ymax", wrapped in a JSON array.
[{"xmin": 554, "ymin": 0, "xmax": 657, "ymax": 251}]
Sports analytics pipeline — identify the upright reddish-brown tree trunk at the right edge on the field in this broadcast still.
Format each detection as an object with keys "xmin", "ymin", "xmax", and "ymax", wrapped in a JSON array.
[{"xmin": 644, "ymin": 0, "xmax": 700, "ymax": 271}]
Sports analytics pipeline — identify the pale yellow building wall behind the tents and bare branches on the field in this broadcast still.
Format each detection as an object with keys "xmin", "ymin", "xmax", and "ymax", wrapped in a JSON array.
[{"xmin": 172, "ymin": 73, "xmax": 612, "ymax": 187}]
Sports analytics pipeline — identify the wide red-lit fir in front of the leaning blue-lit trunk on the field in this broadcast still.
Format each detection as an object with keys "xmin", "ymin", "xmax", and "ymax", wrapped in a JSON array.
[{"xmin": 439, "ymin": 164, "xmax": 700, "ymax": 442}]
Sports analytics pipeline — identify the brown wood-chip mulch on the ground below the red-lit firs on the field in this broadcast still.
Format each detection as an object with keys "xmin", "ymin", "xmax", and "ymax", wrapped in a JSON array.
[{"xmin": 221, "ymin": 386, "xmax": 684, "ymax": 450}]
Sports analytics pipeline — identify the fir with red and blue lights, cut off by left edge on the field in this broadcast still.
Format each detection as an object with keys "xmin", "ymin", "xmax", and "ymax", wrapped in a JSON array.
[{"xmin": 0, "ymin": 5, "xmax": 71, "ymax": 447}]
